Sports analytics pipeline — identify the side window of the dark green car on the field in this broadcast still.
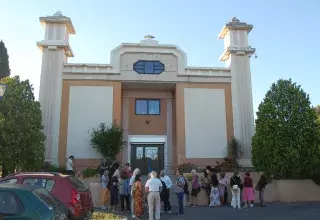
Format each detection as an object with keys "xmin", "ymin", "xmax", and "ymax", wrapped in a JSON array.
[{"xmin": 0, "ymin": 191, "xmax": 24, "ymax": 216}]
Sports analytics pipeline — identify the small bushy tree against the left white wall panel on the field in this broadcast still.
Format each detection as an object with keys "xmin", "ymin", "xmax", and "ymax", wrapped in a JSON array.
[{"xmin": 90, "ymin": 123, "xmax": 126, "ymax": 160}]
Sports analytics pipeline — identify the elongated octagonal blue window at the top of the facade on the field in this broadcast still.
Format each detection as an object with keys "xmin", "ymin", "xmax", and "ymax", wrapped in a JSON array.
[{"xmin": 133, "ymin": 60, "xmax": 164, "ymax": 74}]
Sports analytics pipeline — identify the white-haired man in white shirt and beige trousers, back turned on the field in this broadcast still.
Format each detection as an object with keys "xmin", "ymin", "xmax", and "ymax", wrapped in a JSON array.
[{"xmin": 145, "ymin": 171, "xmax": 162, "ymax": 220}]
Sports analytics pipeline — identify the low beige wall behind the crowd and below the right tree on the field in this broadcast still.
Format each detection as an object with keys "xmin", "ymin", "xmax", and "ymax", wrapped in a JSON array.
[{"xmin": 84, "ymin": 172, "xmax": 320, "ymax": 207}]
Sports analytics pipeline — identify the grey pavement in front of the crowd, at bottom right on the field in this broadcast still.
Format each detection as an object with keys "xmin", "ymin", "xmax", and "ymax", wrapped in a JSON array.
[{"xmin": 96, "ymin": 203, "xmax": 320, "ymax": 220}]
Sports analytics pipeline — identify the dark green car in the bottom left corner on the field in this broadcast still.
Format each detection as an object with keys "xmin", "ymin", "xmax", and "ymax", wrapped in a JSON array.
[{"xmin": 0, "ymin": 184, "xmax": 68, "ymax": 220}]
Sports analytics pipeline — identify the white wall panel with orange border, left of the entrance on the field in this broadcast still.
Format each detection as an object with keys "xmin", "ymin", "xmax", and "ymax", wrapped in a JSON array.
[{"xmin": 59, "ymin": 80, "xmax": 121, "ymax": 169}]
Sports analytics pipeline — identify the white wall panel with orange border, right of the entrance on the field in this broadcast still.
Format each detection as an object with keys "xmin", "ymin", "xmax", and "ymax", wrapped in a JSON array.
[{"xmin": 175, "ymin": 83, "xmax": 233, "ymax": 166}]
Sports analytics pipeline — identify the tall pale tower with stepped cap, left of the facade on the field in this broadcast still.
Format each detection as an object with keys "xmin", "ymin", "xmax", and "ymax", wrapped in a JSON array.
[{"xmin": 37, "ymin": 12, "xmax": 75, "ymax": 165}]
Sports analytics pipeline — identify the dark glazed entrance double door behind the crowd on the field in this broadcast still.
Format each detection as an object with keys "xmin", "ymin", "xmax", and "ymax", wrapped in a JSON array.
[{"xmin": 131, "ymin": 144, "xmax": 164, "ymax": 175}]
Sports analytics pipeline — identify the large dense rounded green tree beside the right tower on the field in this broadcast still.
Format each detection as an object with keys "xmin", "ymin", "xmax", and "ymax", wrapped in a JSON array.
[{"xmin": 252, "ymin": 79, "xmax": 320, "ymax": 178}]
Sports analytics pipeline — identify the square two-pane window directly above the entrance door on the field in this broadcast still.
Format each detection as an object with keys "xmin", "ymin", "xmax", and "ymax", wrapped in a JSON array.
[{"xmin": 136, "ymin": 99, "xmax": 160, "ymax": 115}]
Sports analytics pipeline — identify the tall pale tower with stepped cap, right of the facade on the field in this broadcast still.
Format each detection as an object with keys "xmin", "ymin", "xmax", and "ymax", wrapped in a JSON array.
[{"xmin": 219, "ymin": 17, "xmax": 255, "ymax": 167}]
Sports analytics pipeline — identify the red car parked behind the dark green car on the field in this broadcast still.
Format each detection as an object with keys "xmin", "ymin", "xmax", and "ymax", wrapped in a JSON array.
[{"xmin": 0, "ymin": 172, "xmax": 93, "ymax": 219}]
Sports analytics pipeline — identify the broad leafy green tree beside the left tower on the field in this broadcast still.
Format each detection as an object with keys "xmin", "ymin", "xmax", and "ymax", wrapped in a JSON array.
[{"xmin": 0, "ymin": 76, "xmax": 45, "ymax": 172}]
